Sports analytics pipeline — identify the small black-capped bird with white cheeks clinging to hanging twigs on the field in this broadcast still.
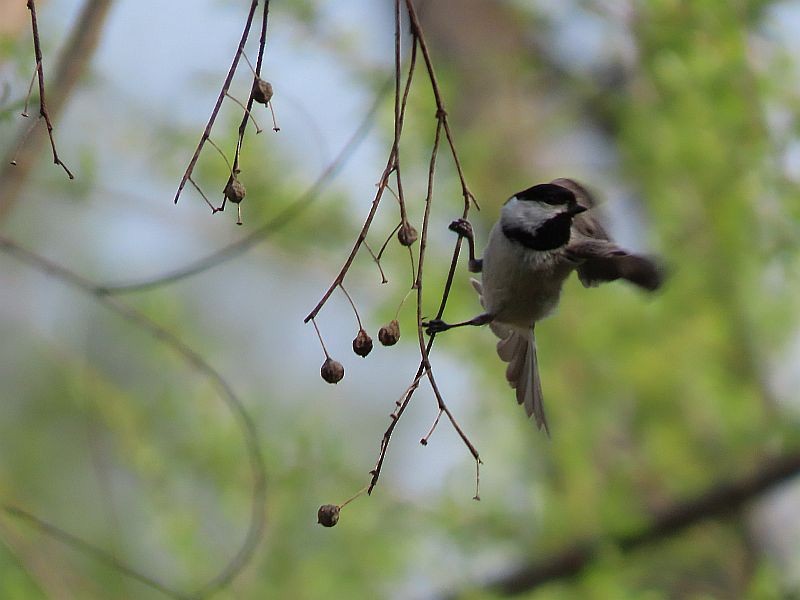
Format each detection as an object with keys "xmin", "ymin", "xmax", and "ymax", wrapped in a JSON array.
[{"xmin": 423, "ymin": 179, "xmax": 662, "ymax": 435}]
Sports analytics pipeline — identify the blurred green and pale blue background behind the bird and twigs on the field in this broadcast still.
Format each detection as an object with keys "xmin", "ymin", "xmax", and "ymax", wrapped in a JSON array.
[{"xmin": 0, "ymin": 0, "xmax": 800, "ymax": 599}]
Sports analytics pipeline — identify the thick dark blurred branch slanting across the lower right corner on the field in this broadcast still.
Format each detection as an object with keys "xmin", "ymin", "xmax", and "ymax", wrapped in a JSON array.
[{"xmin": 443, "ymin": 452, "xmax": 800, "ymax": 598}]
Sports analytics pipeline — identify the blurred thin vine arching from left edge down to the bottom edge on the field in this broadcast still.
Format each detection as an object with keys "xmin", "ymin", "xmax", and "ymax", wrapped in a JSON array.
[{"xmin": 0, "ymin": 235, "xmax": 266, "ymax": 596}]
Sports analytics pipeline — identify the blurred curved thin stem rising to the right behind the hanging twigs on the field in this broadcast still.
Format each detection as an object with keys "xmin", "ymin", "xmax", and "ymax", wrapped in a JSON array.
[{"xmin": 94, "ymin": 80, "xmax": 391, "ymax": 295}]
